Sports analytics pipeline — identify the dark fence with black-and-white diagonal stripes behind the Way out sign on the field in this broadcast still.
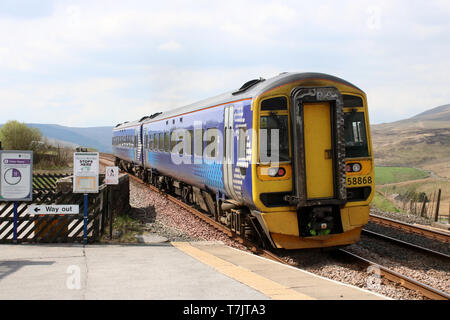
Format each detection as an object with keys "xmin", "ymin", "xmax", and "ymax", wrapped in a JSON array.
[{"xmin": 0, "ymin": 175, "xmax": 112, "ymax": 243}]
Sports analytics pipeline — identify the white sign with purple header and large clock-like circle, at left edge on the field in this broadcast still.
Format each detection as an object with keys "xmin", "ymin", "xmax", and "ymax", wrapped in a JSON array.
[{"xmin": 0, "ymin": 150, "xmax": 33, "ymax": 201}]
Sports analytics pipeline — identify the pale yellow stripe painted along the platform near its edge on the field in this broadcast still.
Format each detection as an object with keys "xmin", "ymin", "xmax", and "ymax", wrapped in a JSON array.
[{"xmin": 172, "ymin": 242, "xmax": 315, "ymax": 300}]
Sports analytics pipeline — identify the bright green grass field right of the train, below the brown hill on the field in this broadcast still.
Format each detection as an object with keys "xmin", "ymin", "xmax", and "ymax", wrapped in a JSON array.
[{"xmin": 375, "ymin": 167, "xmax": 429, "ymax": 185}]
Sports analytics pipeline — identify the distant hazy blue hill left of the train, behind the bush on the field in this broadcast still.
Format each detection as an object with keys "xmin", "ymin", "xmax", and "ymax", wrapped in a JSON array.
[{"xmin": 0, "ymin": 123, "xmax": 113, "ymax": 153}]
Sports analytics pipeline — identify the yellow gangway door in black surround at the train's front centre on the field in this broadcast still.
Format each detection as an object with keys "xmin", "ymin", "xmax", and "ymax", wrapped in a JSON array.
[{"xmin": 291, "ymin": 87, "xmax": 346, "ymax": 207}]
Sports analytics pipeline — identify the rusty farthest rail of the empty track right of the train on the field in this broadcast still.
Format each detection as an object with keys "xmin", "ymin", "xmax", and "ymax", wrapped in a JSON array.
[{"xmin": 369, "ymin": 214, "xmax": 450, "ymax": 243}]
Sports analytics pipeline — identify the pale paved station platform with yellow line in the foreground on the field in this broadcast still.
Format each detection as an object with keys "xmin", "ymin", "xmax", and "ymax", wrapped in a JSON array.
[{"xmin": 0, "ymin": 242, "xmax": 386, "ymax": 300}]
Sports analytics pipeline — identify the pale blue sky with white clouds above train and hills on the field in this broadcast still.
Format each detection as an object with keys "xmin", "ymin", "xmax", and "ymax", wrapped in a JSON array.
[{"xmin": 0, "ymin": 0, "xmax": 450, "ymax": 127}]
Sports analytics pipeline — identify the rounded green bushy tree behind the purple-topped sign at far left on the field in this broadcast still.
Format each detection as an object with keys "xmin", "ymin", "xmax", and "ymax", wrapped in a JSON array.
[{"xmin": 0, "ymin": 120, "xmax": 42, "ymax": 151}]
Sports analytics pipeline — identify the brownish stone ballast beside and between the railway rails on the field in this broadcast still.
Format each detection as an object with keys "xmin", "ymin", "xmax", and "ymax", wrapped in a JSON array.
[{"xmin": 99, "ymin": 159, "xmax": 450, "ymax": 300}]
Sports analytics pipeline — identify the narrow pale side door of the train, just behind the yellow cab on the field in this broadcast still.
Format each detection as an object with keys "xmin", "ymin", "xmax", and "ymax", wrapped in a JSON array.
[{"xmin": 223, "ymin": 105, "xmax": 238, "ymax": 200}]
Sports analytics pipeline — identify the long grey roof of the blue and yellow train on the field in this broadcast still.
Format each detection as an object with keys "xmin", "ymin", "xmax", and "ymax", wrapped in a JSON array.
[{"xmin": 115, "ymin": 72, "xmax": 362, "ymax": 130}]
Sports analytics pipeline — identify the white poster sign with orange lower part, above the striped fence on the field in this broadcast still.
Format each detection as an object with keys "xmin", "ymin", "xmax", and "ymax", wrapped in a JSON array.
[{"xmin": 73, "ymin": 152, "xmax": 99, "ymax": 193}]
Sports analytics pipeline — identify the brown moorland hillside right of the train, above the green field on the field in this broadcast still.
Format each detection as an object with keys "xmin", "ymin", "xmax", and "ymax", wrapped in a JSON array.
[{"xmin": 371, "ymin": 104, "xmax": 450, "ymax": 177}]
